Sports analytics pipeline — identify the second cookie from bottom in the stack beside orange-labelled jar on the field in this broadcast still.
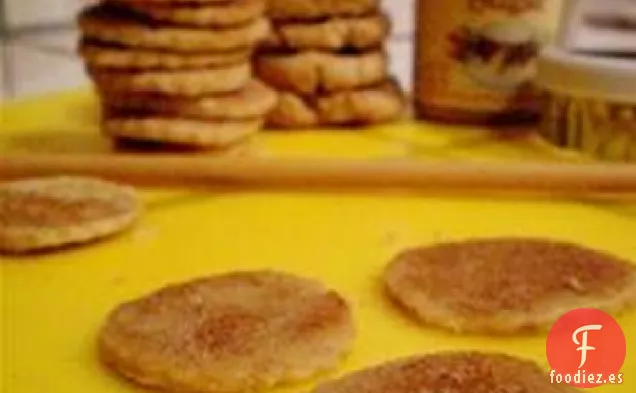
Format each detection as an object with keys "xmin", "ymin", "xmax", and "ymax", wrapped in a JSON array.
[{"xmin": 255, "ymin": 51, "xmax": 388, "ymax": 95}]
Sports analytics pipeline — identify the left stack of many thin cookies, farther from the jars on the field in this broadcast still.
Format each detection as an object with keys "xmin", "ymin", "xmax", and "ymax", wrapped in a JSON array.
[{"xmin": 79, "ymin": 0, "xmax": 277, "ymax": 149}]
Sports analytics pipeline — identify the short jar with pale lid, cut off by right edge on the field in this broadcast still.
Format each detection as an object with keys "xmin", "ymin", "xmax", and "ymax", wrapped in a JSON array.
[{"xmin": 537, "ymin": 47, "xmax": 636, "ymax": 163}]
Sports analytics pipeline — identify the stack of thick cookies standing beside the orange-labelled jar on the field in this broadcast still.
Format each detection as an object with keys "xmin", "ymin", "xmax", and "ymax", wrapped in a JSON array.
[{"xmin": 254, "ymin": 0, "xmax": 406, "ymax": 128}]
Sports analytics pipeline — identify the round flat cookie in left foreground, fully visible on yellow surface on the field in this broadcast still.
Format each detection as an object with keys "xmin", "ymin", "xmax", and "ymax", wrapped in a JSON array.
[{"xmin": 99, "ymin": 272, "xmax": 355, "ymax": 393}]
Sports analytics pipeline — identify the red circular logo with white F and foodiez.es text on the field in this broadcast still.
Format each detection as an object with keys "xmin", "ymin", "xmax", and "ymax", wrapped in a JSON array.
[{"xmin": 546, "ymin": 308, "xmax": 627, "ymax": 388}]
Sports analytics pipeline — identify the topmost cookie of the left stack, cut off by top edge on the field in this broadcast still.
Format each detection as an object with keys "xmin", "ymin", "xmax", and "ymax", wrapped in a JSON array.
[{"xmin": 122, "ymin": 0, "xmax": 266, "ymax": 27}]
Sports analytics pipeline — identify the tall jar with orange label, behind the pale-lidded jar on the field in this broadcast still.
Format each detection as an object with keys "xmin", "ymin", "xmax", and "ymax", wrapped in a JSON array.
[{"xmin": 414, "ymin": 0, "xmax": 562, "ymax": 123}]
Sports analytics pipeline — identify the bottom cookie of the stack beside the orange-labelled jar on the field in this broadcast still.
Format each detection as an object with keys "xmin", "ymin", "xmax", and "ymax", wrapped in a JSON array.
[{"xmin": 267, "ymin": 81, "xmax": 406, "ymax": 128}]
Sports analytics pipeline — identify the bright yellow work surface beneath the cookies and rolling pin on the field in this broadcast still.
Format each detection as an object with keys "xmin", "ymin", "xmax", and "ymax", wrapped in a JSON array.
[{"xmin": 0, "ymin": 91, "xmax": 636, "ymax": 393}]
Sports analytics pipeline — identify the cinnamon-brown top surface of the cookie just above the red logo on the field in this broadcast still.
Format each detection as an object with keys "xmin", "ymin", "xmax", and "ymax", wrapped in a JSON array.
[{"xmin": 391, "ymin": 239, "xmax": 635, "ymax": 313}]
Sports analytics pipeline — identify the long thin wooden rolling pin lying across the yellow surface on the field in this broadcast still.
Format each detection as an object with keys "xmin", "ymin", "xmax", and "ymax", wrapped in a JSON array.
[{"xmin": 0, "ymin": 154, "xmax": 636, "ymax": 194}]
